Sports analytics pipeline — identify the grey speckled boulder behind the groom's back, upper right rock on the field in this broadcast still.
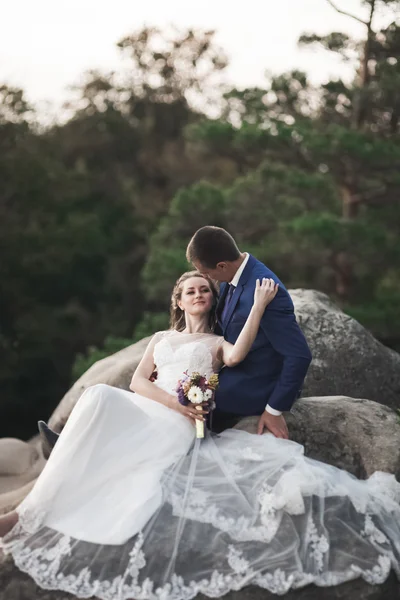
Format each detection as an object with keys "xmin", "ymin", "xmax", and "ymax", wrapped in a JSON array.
[{"xmin": 290, "ymin": 289, "xmax": 400, "ymax": 408}]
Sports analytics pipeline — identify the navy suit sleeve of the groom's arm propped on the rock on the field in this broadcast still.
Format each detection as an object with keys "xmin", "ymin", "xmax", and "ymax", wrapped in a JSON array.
[{"xmin": 261, "ymin": 290, "xmax": 312, "ymax": 411}]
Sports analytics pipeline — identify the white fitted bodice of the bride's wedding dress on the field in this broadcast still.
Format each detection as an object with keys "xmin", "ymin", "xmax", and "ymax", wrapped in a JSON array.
[{"xmin": 154, "ymin": 331, "xmax": 223, "ymax": 393}]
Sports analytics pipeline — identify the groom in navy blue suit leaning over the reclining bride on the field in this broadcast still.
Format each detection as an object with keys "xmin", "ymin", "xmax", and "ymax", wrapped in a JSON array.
[{"xmin": 186, "ymin": 226, "xmax": 311, "ymax": 439}]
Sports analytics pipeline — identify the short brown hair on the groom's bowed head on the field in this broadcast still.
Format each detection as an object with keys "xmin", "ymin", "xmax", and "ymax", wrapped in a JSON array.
[{"xmin": 186, "ymin": 225, "xmax": 240, "ymax": 269}]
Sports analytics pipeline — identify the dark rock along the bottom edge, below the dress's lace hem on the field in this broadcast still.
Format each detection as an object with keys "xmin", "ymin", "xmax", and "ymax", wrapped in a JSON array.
[{"xmin": 0, "ymin": 557, "xmax": 400, "ymax": 600}]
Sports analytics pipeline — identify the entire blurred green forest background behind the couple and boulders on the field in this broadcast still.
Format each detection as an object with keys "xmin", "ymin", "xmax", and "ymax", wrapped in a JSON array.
[{"xmin": 0, "ymin": 10, "xmax": 400, "ymax": 437}]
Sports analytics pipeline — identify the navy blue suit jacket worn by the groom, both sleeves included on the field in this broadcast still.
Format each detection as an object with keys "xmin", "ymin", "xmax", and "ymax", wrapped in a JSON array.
[{"xmin": 215, "ymin": 255, "xmax": 311, "ymax": 415}]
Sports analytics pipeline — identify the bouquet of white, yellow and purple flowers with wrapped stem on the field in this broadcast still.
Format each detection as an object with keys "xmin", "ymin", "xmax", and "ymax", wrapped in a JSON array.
[{"xmin": 176, "ymin": 371, "xmax": 218, "ymax": 438}]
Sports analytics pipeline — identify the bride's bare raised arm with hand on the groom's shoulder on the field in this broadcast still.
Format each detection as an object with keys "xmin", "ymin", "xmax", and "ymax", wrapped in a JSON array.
[{"xmin": 219, "ymin": 278, "xmax": 279, "ymax": 367}]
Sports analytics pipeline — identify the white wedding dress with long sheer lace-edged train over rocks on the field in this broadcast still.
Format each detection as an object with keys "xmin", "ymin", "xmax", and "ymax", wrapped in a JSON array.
[{"xmin": 2, "ymin": 331, "xmax": 400, "ymax": 600}]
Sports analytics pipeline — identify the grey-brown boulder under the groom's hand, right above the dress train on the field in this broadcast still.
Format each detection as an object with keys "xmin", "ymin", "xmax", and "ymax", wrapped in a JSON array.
[{"xmin": 236, "ymin": 396, "xmax": 400, "ymax": 479}]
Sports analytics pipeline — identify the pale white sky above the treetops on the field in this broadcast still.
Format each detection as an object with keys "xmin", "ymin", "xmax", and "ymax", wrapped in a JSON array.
[{"xmin": 0, "ymin": 0, "xmax": 394, "ymax": 120}]
